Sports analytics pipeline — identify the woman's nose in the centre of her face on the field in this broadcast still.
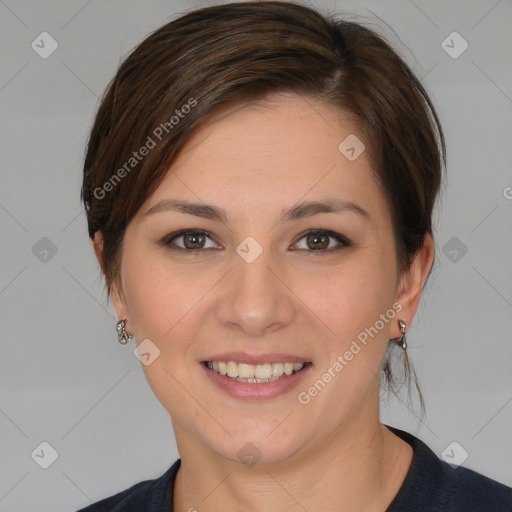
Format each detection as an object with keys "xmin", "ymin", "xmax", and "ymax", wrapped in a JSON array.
[{"xmin": 217, "ymin": 242, "xmax": 296, "ymax": 338}]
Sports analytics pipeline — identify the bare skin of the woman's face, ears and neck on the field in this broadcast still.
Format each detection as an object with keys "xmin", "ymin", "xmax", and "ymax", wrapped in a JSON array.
[{"xmin": 94, "ymin": 94, "xmax": 434, "ymax": 512}]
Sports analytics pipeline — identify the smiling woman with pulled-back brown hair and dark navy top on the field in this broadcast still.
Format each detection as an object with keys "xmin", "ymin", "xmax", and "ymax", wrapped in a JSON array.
[{"xmin": 77, "ymin": 2, "xmax": 512, "ymax": 512}]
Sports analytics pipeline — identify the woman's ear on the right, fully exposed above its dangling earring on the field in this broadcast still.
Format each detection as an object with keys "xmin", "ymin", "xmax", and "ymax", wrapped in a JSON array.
[{"xmin": 391, "ymin": 233, "xmax": 435, "ymax": 337}]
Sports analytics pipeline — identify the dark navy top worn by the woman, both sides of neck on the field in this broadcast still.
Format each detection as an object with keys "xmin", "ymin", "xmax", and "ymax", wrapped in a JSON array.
[{"xmin": 77, "ymin": 425, "xmax": 512, "ymax": 512}]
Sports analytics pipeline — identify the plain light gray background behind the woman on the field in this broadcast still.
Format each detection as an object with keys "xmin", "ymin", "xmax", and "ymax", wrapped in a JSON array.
[{"xmin": 0, "ymin": 0, "xmax": 512, "ymax": 512}]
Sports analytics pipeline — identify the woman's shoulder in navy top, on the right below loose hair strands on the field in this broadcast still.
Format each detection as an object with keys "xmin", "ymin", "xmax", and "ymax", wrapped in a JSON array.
[{"xmin": 386, "ymin": 425, "xmax": 512, "ymax": 512}]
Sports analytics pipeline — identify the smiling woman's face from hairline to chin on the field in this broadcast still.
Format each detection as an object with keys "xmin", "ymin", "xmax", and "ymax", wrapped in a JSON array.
[{"xmin": 107, "ymin": 94, "xmax": 428, "ymax": 463}]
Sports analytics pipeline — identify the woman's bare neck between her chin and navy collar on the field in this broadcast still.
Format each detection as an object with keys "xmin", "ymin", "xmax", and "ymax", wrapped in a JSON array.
[{"xmin": 174, "ymin": 417, "xmax": 412, "ymax": 512}]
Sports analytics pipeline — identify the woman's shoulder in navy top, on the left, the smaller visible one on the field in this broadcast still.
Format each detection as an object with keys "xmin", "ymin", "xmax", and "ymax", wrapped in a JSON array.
[{"xmin": 77, "ymin": 459, "xmax": 181, "ymax": 512}]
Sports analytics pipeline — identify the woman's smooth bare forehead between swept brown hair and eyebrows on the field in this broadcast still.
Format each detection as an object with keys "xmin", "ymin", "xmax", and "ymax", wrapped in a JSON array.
[{"xmin": 138, "ymin": 93, "xmax": 386, "ymax": 220}]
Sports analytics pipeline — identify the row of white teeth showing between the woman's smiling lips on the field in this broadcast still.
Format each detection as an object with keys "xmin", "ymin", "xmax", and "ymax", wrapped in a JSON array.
[{"xmin": 203, "ymin": 361, "xmax": 311, "ymax": 384}]
